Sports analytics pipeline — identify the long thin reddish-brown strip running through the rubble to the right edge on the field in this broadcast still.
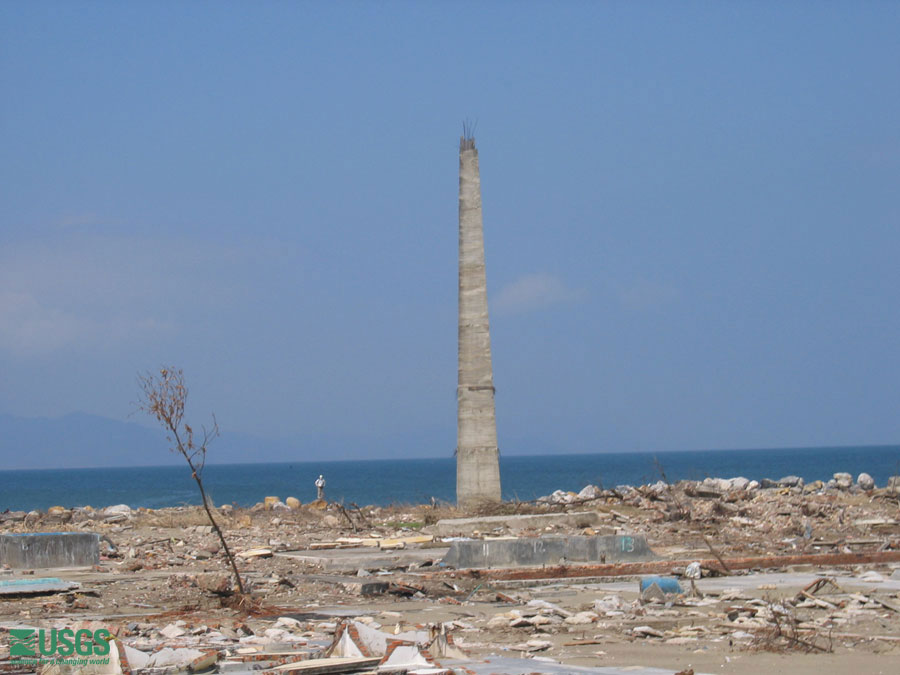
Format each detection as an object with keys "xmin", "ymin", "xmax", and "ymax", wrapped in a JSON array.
[{"xmin": 423, "ymin": 551, "xmax": 900, "ymax": 581}]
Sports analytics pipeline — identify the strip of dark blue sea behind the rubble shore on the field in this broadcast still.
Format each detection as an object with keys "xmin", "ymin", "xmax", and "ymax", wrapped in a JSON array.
[{"xmin": 0, "ymin": 445, "xmax": 900, "ymax": 512}]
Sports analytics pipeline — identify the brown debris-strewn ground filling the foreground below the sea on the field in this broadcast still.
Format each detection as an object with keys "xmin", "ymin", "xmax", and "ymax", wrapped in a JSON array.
[{"xmin": 0, "ymin": 474, "xmax": 900, "ymax": 673}]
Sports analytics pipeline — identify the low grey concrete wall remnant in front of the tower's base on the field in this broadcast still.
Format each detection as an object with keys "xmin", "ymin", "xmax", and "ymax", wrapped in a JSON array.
[{"xmin": 443, "ymin": 535, "xmax": 659, "ymax": 569}]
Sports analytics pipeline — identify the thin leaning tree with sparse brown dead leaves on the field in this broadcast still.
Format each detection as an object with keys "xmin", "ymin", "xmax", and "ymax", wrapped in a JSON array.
[{"xmin": 137, "ymin": 367, "xmax": 244, "ymax": 595}]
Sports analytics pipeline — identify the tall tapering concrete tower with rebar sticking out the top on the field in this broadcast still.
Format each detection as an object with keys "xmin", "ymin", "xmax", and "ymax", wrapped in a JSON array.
[{"xmin": 456, "ymin": 133, "xmax": 500, "ymax": 508}]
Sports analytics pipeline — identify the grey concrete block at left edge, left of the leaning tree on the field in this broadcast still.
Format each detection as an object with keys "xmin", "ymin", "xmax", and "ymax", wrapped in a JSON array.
[{"xmin": 0, "ymin": 532, "xmax": 100, "ymax": 569}]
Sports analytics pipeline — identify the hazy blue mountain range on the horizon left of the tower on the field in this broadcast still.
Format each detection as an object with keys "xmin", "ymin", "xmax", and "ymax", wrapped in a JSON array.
[{"xmin": 0, "ymin": 413, "xmax": 464, "ymax": 469}]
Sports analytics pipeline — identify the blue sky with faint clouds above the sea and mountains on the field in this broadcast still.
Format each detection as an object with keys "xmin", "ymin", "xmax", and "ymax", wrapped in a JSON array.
[{"xmin": 0, "ymin": 1, "xmax": 900, "ymax": 461}]
